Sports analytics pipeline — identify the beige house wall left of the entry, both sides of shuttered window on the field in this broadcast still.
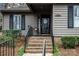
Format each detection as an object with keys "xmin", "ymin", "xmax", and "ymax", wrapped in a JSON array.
[{"xmin": 3, "ymin": 14, "xmax": 37, "ymax": 35}]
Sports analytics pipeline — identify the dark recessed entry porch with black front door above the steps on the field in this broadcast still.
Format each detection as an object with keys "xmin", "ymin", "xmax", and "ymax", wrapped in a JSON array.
[{"xmin": 27, "ymin": 3, "xmax": 52, "ymax": 35}]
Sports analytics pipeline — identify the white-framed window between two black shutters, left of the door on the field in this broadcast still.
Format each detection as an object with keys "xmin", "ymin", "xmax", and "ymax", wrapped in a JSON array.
[{"xmin": 13, "ymin": 15, "xmax": 21, "ymax": 30}]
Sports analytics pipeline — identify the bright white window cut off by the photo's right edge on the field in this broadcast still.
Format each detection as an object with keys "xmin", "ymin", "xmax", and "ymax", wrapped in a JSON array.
[{"xmin": 73, "ymin": 6, "xmax": 79, "ymax": 27}]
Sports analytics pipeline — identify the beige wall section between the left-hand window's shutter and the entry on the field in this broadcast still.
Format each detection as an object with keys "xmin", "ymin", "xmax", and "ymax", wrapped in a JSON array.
[{"xmin": 22, "ymin": 14, "xmax": 37, "ymax": 35}]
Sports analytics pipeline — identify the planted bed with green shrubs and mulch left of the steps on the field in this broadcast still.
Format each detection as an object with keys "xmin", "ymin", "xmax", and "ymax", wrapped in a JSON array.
[{"xmin": 0, "ymin": 30, "xmax": 25, "ymax": 56}]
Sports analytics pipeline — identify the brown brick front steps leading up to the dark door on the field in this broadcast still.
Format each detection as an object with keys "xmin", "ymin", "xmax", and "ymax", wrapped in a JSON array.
[{"xmin": 26, "ymin": 36, "xmax": 52, "ymax": 53}]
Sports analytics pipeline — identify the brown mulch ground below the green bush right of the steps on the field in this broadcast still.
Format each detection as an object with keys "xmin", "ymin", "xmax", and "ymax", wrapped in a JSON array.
[{"xmin": 59, "ymin": 46, "xmax": 79, "ymax": 56}]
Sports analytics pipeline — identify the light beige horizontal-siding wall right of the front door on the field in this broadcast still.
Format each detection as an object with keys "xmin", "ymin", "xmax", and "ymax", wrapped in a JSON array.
[{"xmin": 52, "ymin": 4, "xmax": 79, "ymax": 36}]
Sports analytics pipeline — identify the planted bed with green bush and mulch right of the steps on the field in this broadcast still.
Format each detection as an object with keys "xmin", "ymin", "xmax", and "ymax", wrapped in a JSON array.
[{"xmin": 54, "ymin": 37, "xmax": 79, "ymax": 56}]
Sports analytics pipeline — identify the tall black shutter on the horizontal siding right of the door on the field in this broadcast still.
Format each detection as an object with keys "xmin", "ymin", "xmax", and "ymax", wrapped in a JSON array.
[{"xmin": 68, "ymin": 5, "xmax": 74, "ymax": 28}]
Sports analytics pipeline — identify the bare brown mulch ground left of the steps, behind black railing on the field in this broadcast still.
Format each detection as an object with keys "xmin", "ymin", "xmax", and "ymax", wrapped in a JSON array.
[{"xmin": 1, "ymin": 37, "xmax": 24, "ymax": 56}]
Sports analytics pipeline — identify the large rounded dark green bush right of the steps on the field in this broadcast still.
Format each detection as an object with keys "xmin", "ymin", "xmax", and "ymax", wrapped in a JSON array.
[{"xmin": 61, "ymin": 36, "xmax": 76, "ymax": 48}]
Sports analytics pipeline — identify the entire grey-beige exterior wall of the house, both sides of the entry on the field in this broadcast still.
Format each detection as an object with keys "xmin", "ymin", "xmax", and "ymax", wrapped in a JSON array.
[{"xmin": 3, "ymin": 4, "xmax": 79, "ymax": 36}]
